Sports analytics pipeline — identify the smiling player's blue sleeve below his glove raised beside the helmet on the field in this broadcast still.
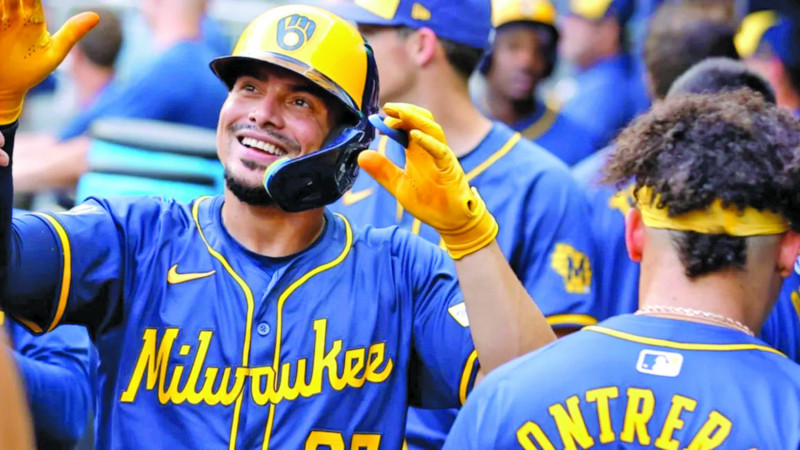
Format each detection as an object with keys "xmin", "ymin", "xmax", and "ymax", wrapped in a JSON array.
[{"xmin": 396, "ymin": 232, "xmax": 478, "ymax": 408}]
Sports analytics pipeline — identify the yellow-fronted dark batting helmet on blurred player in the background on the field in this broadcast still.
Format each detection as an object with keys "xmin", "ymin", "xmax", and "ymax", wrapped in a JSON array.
[{"xmin": 480, "ymin": 0, "xmax": 558, "ymax": 77}]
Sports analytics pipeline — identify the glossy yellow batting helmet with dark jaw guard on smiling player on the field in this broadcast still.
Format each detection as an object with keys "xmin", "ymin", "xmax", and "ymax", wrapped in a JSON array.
[{"xmin": 211, "ymin": 5, "xmax": 378, "ymax": 212}]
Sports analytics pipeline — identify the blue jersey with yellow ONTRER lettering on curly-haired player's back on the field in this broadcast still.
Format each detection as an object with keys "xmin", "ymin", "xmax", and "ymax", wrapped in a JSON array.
[{"xmin": 444, "ymin": 315, "xmax": 800, "ymax": 450}]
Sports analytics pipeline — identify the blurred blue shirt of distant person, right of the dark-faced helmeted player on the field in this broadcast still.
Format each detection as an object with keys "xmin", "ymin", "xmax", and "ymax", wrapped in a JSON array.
[{"xmin": 557, "ymin": 54, "xmax": 650, "ymax": 149}]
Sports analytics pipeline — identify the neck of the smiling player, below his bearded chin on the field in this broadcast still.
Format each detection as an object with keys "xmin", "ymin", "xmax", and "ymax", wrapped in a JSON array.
[{"xmin": 222, "ymin": 190, "xmax": 325, "ymax": 258}]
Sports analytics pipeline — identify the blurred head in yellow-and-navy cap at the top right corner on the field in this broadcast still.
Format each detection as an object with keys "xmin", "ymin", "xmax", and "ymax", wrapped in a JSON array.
[{"xmin": 736, "ymin": 11, "xmax": 800, "ymax": 116}]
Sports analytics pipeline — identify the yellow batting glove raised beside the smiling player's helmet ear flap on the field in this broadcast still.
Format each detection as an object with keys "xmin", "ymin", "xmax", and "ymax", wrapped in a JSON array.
[{"xmin": 358, "ymin": 103, "xmax": 498, "ymax": 259}]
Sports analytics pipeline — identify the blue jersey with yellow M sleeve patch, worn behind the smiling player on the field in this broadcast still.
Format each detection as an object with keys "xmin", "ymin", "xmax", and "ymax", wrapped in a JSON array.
[{"xmin": 333, "ymin": 122, "xmax": 596, "ymax": 449}]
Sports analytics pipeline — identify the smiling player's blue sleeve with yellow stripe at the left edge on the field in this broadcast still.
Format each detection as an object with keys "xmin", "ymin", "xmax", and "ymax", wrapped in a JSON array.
[{"xmin": 4, "ymin": 198, "xmax": 177, "ymax": 334}]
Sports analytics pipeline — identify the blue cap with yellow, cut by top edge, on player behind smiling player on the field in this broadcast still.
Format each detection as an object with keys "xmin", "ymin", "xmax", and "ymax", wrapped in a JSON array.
[{"xmin": 331, "ymin": 0, "xmax": 492, "ymax": 49}]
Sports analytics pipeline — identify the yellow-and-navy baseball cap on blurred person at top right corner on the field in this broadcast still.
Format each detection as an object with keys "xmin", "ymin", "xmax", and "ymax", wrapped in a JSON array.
[{"xmin": 734, "ymin": 11, "xmax": 800, "ymax": 67}]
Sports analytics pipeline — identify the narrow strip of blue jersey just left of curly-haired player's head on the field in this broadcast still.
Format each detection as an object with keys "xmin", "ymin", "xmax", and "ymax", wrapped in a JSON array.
[{"xmin": 572, "ymin": 147, "xmax": 639, "ymax": 320}]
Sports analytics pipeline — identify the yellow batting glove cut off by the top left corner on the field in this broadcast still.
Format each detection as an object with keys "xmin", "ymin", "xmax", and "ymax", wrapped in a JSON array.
[{"xmin": 0, "ymin": 0, "xmax": 99, "ymax": 125}]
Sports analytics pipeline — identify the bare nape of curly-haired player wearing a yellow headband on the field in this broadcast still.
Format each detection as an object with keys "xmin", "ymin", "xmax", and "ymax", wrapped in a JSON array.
[{"xmin": 639, "ymin": 239, "xmax": 777, "ymax": 333}]
